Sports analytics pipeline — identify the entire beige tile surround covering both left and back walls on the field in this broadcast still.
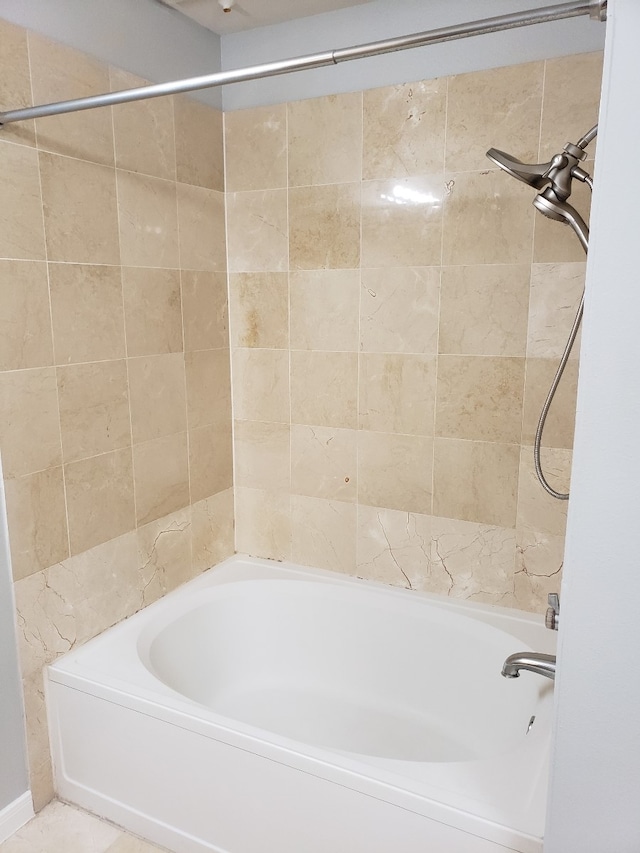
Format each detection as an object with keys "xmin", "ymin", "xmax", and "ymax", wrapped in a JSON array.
[{"xmin": 0, "ymin": 13, "xmax": 600, "ymax": 806}]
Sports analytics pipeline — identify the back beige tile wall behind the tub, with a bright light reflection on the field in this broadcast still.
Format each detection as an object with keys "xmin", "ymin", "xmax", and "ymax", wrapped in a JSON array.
[{"xmin": 225, "ymin": 54, "xmax": 601, "ymax": 611}]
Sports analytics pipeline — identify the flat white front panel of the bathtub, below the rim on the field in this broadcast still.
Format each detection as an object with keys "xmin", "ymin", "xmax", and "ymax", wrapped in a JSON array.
[{"xmin": 49, "ymin": 683, "xmax": 542, "ymax": 853}]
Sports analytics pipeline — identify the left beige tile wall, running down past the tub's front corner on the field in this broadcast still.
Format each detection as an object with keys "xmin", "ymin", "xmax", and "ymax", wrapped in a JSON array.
[{"xmin": 0, "ymin": 22, "xmax": 233, "ymax": 807}]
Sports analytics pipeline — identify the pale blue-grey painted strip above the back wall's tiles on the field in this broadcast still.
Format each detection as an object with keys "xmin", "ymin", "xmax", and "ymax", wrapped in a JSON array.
[{"xmin": 222, "ymin": 0, "xmax": 605, "ymax": 110}]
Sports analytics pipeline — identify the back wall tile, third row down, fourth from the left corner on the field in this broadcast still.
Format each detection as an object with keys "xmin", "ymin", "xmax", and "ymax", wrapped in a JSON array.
[{"xmin": 438, "ymin": 264, "xmax": 531, "ymax": 356}]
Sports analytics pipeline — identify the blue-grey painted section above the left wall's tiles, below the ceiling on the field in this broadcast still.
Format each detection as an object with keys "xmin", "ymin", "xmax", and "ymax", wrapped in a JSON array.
[{"xmin": 0, "ymin": 0, "xmax": 222, "ymax": 109}]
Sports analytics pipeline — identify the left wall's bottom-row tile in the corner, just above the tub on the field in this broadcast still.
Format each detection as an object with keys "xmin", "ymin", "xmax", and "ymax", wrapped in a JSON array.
[{"xmin": 191, "ymin": 489, "xmax": 235, "ymax": 573}]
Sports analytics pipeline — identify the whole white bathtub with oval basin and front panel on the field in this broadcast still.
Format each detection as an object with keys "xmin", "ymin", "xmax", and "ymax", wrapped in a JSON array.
[{"xmin": 47, "ymin": 557, "xmax": 554, "ymax": 853}]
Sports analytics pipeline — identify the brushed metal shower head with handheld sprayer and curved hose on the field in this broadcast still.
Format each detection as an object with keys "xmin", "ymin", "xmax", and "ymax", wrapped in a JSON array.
[{"xmin": 487, "ymin": 124, "xmax": 598, "ymax": 501}]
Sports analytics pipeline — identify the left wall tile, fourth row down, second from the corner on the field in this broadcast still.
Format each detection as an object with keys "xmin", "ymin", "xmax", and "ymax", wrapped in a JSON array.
[{"xmin": 128, "ymin": 353, "xmax": 187, "ymax": 444}]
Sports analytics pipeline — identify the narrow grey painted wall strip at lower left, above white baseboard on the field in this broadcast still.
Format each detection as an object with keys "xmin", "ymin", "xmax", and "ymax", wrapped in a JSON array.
[{"xmin": 0, "ymin": 469, "xmax": 29, "ymax": 812}]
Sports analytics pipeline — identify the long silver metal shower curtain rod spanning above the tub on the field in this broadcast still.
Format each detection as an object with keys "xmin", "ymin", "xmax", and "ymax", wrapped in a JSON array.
[{"xmin": 0, "ymin": 0, "xmax": 607, "ymax": 126}]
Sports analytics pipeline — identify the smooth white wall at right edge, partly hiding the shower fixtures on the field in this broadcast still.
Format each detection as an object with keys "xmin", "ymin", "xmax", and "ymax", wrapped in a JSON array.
[{"xmin": 545, "ymin": 0, "xmax": 640, "ymax": 853}]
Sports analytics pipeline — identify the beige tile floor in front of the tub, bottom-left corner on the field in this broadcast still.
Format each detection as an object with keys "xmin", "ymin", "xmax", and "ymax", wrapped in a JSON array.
[{"xmin": 0, "ymin": 800, "xmax": 168, "ymax": 853}]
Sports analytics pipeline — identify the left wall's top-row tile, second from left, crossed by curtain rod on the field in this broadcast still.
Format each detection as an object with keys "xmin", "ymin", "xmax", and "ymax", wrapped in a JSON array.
[{"xmin": 29, "ymin": 32, "xmax": 114, "ymax": 166}]
